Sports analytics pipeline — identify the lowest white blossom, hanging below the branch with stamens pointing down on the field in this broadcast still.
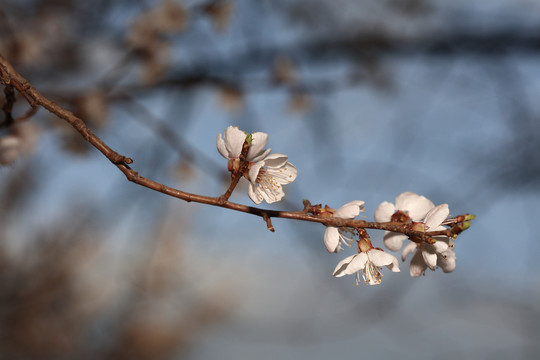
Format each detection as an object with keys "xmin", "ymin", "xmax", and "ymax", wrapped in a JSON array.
[{"xmin": 333, "ymin": 248, "xmax": 399, "ymax": 285}]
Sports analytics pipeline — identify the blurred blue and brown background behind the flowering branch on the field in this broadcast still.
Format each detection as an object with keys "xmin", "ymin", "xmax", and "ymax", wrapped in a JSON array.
[{"xmin": 0, "ymin": 0, "xmax": 540, "ymax": 360}]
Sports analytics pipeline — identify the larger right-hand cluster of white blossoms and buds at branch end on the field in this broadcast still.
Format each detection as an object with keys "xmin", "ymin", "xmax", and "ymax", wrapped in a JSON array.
[{"xmin": 312, "ymin": 192, "xmax": 474, "ymax": 285}]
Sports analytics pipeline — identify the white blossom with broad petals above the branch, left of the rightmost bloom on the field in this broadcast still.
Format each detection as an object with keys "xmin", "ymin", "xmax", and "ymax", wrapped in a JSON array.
[{"xmin": 375, "ymin": 192, "xmax": 435, "ymax": 251}]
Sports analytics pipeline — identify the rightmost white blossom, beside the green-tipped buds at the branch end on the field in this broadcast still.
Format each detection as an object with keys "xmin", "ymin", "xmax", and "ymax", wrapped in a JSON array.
[{"xmin": 401, "ymin": 204, "xmax": 456, "ymax": 277}]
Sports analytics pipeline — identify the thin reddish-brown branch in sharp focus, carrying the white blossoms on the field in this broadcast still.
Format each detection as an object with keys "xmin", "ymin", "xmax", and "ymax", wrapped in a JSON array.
[{"xmin": 0, "ymin": 55, "xmax": 468, "ymax": 241}]
